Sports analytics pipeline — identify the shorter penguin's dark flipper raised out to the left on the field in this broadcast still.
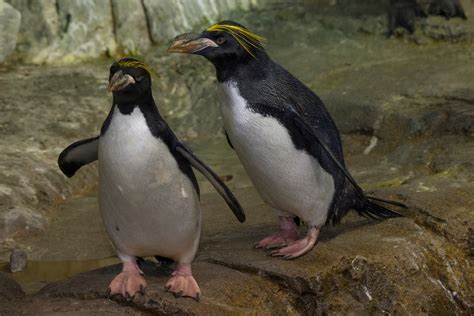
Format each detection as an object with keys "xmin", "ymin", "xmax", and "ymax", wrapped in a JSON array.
[{"xmin": 58, "ymin": 136, "xmax": 99, "ymax": 178}]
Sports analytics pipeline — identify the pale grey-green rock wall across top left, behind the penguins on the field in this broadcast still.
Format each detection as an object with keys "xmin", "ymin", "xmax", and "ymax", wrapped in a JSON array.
[{"xmin": 0, "ymin": 0, "xmax": 263, "ymax": 64}]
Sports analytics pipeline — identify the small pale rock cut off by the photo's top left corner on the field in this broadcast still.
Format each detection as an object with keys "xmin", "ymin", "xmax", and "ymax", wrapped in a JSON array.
[{"xmin": 0, "ymin": 0, "xmax": 21, "ymax": 63}]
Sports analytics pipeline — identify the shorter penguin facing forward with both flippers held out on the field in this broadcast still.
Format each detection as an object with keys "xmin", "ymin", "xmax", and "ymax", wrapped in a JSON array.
[{"xmin": 58, "ymin": 58, "xmax": 245, "ymax": 300}]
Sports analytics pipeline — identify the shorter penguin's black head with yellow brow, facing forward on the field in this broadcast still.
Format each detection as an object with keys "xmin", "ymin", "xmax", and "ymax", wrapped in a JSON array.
[{"xmin": 108, "ymin": 58, "xmax": 152, "ymax": 103}]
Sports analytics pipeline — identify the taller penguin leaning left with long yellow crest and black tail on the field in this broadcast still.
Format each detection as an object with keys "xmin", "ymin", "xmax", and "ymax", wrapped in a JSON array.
[{"xmin": 168, "ymin": 21, "xmax": 406, "ymax": 259}]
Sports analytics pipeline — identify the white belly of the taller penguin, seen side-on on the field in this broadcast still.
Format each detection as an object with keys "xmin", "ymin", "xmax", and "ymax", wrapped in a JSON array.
[{"xmin": 218, "ymin": 82, "xmax": 334, "ymax": 227}]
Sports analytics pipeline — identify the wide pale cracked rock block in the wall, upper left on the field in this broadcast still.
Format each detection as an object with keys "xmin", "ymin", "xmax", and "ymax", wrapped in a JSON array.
[{"xmin": 10, "ymin": 0, "xmax": 116, "ymax": 64}]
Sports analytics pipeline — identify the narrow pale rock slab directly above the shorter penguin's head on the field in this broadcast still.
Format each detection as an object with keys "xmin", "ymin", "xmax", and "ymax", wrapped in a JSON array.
[{"xmin": 111, "ymin": 0, "xmax": 151, "ymax": 55}]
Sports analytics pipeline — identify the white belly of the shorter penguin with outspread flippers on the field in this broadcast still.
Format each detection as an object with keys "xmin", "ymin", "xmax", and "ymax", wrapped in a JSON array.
[{"xmin": 99, "ymin": 108, "xmax": 201, "ymax": 261}]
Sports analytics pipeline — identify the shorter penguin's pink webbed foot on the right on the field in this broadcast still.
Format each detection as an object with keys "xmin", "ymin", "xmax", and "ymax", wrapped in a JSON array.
[{"xmin": 165, "ymin": 263, "xmax": 201, "ymax": 301}]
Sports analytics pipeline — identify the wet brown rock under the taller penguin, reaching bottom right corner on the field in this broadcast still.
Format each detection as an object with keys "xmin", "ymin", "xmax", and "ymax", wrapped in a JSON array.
[{"xmin": 200, "ymin": 190, "xmax": 474, "ymax": 314}]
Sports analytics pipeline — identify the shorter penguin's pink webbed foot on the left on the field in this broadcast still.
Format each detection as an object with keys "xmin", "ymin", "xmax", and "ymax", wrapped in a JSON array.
[{"xmin": 107, "ymin": 260, "xmax": 146, "ymax": 300}]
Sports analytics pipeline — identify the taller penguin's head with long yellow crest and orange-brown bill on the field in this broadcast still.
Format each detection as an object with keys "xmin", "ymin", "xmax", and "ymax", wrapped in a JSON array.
[{"xmin": 168, "ymin": 21, "xmax": 268, "ymax": 77}]
